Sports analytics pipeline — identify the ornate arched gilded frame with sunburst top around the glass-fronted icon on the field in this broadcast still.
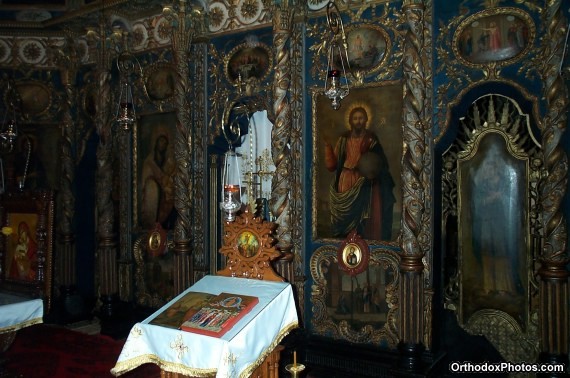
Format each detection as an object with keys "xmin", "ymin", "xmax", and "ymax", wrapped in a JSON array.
[{"xmin": 442, "ymin": 94, "xmax": 542, "ymax": 362}]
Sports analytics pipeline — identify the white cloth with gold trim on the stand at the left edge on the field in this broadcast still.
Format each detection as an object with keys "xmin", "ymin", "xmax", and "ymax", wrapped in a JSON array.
[{"xmin": 0, "ymin": 293, "xmax": 44, "ymax": 333}]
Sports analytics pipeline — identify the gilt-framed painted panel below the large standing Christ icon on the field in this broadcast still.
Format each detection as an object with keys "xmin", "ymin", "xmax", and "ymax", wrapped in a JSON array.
[{"xmin": 309, "ymin": 246, "xmax": 401, "ymax": 348}]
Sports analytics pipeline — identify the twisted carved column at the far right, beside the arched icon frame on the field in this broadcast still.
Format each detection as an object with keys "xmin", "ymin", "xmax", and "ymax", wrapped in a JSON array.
[{"xmin": 538, "ymin": 0, "xmax": 570, "ymax": 368}]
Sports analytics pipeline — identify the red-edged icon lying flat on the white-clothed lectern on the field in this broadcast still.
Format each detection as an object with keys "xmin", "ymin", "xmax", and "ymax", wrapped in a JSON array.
[{"xmin": 180, "ymin": 293, "xmax": 259, "ymax": 337}]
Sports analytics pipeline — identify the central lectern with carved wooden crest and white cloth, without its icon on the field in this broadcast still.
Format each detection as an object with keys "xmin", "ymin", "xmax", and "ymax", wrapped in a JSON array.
[{"xmin": 111, "ymin": 211, "xmax": 298, "ymax": 378}]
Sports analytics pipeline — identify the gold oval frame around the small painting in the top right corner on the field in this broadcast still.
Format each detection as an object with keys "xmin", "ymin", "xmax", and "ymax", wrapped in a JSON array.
[{"xmin": 451, "ymin": 7, "xmax": 536, "ymax": 68}]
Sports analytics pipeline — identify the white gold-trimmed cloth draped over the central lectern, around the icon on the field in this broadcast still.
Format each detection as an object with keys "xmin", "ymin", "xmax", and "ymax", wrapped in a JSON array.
[{"xmin": 111, "ymin": 276, "xmax": 298, "ymax": 377}]
